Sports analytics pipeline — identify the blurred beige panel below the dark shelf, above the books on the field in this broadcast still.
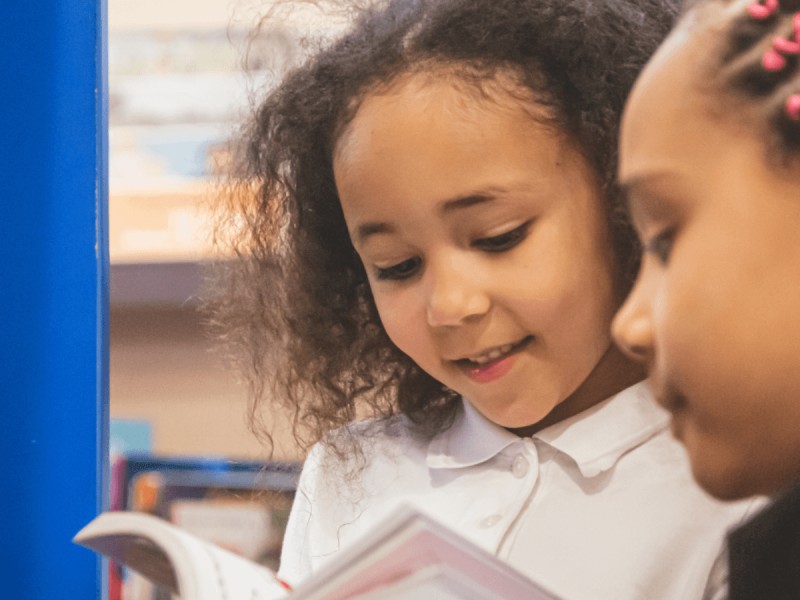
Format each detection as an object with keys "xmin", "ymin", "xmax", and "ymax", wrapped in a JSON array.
[{"xmin": 110, "ymin": 308, "xmax": 297, "ymax": 459}]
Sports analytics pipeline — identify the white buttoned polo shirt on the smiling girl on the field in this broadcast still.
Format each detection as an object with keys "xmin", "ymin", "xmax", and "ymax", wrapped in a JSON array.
[{"xmin": 280, "ymin": 382, "xmax": 760, "ymax": 600}]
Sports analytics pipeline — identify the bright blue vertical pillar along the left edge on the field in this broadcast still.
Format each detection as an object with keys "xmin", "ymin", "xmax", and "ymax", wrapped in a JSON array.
[{"xmin": 0, "ymin": 0, "xmax": 108, "ymax": 600}]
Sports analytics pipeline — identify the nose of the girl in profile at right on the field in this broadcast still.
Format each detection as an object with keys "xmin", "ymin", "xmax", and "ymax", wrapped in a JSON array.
[{"xmin": 611, "ymin": 273, "xmax": 655, "ymax": 363}]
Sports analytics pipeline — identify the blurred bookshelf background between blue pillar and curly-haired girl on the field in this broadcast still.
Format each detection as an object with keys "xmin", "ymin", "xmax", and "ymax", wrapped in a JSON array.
[{"xmin": 106, "ymin": 0, "xmax": 332, "ymax": 600}]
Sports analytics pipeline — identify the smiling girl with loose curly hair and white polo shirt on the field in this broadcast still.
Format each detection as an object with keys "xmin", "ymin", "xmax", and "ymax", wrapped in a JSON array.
[{"xmin": 211, "ymin": 0, "xmax": 748, "ymax": 600}]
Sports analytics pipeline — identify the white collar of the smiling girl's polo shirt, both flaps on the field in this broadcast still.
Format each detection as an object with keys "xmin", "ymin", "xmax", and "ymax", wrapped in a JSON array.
[{"xmin": 427, "ymin": 382, "xmax": 669, "ymax": 477}]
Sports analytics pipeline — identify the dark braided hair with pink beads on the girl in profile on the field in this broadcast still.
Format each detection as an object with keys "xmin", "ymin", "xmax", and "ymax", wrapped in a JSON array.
[{"xmin": 683, "ymin": 0, "xmax": 800, "ymax": 165}]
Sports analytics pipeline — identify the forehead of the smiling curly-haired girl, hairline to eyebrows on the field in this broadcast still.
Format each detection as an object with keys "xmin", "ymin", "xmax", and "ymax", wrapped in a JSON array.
[{"xmin": 333, "ymin": 67, "xmax": 596, "ymax": 232}]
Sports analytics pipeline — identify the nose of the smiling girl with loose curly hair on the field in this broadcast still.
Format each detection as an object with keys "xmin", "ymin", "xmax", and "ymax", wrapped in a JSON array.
[{"xmin": 425, "ymin": 257, "xmax": 491, "ymax": 327}]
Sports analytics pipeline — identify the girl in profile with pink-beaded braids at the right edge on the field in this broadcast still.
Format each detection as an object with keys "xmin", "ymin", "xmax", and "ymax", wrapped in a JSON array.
[{"xmin": 614, "ymin": 0, "xmax": 800, "ymax": 600}]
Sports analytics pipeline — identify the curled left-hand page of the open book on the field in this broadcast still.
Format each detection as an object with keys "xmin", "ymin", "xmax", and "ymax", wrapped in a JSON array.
[{"xmin": 75, "ymin": 512, "xmax": 288, "ymax": 600}]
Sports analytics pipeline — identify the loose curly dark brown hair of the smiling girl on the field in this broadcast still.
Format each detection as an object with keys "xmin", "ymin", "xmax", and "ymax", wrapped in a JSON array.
[{"xmin": 206, "ymin": 0, "xmax": 679, "ymax": 454}]
